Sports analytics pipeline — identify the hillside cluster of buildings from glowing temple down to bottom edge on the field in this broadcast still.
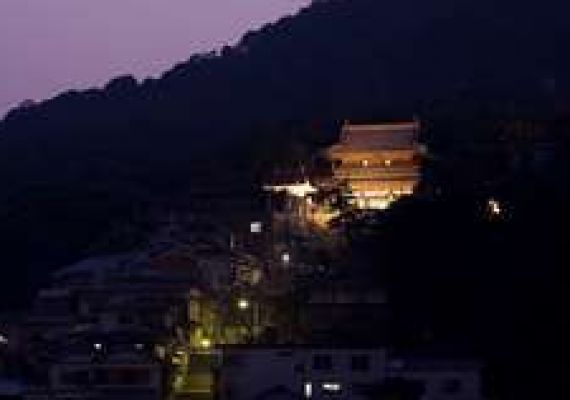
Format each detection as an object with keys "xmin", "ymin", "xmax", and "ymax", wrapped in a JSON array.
[{"xmin": 0, "ymin": 122, "xmax": 482, "ymax": 400}]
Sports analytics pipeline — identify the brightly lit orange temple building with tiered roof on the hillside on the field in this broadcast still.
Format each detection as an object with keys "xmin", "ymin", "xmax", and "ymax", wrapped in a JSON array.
[{"xmin": 326, "ymin": 122, "xmax": 421, "ymax": 209}]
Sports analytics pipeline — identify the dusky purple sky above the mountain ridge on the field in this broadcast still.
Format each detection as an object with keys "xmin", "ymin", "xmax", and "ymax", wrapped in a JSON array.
[{"xmin": 0, "ymin": 0, "xmax": 310, "ymax": 116}]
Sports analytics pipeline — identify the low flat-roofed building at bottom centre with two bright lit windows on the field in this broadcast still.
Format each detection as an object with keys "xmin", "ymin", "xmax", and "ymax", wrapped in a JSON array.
[{"xmin": 219, "ymin": 346, "xmax": 482, "ymax": 400}]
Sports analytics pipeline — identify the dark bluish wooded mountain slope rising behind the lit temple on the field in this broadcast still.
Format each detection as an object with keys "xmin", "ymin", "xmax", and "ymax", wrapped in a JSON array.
[{"xmin": 0, "ymin": 0, "xmax": 570, "ymax": 306}]
